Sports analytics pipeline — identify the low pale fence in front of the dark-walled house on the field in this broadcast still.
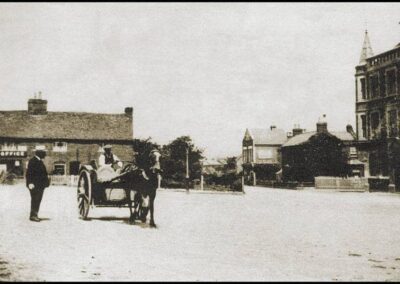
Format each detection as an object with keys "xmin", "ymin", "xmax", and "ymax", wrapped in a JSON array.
[{"xmin": 315, "ymin": 177, "xmax": 368, "ymax": 191}]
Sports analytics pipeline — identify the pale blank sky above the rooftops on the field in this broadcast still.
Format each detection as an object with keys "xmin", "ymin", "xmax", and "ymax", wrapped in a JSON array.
[{"xmin": 0, "ymin": 3, "xmax": 400, "ymax": 158}]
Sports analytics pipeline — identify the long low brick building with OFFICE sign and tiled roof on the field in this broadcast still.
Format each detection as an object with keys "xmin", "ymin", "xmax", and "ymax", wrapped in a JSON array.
[{"xmin": 0, "ymin": 97, "xmax": 134, "ymax": 177}]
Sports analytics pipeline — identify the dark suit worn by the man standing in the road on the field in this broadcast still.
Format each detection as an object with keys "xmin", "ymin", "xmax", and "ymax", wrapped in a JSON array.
[{"xmin": 26, "ymin": 156, "xmax": 50, "ymax": 217}]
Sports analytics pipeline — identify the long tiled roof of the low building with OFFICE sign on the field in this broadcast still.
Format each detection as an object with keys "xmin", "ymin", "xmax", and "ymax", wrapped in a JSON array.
[{"xmin": 0, "ymin": 111, "xmax": 133, "ymax": 140}]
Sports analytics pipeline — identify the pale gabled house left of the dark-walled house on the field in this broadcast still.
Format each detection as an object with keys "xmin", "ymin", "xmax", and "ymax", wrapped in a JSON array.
[{"xmin": 242, "ymin": 126, "xmax": 288, "ymax": 181}]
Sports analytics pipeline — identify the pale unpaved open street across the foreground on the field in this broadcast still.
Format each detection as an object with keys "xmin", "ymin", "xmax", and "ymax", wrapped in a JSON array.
[{"xmin": 0, "ymin": 185, "xmax": 400, "ymax": 281}]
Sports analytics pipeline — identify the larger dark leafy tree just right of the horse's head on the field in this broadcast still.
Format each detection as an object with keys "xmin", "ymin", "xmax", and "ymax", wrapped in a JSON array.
[{"xmin": 161, "ymin": 136, "xmax": 203, "ymax": 181}]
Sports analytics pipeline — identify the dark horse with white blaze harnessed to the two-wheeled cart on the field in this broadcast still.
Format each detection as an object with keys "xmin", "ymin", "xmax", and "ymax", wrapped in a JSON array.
[{"xmin": 121, "ymin": 150, "xmax": 161, "ymax": 227}]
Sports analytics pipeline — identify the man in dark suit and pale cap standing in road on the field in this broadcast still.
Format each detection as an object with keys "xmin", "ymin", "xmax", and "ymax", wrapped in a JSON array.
[{"xmin": 26, "ymin": 146, "xmax": 50, "ymax": 222}]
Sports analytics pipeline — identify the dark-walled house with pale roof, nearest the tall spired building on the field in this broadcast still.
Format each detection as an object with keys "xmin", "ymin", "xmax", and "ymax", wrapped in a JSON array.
[{"xmin": 282, "ymin": 117, "xmax": 363, "ymax": 182}]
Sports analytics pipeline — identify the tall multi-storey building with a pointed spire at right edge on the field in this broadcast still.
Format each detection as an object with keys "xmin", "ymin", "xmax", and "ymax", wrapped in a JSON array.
[{"xmin": 355, "ymin": 31, "xmax": 400, "ymax": 188}]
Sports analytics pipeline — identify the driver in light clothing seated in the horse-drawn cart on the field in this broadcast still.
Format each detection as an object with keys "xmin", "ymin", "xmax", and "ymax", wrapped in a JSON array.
[{"xmin": 97, "ymin": 144, "xmax": 122, "ymax": 182}]
